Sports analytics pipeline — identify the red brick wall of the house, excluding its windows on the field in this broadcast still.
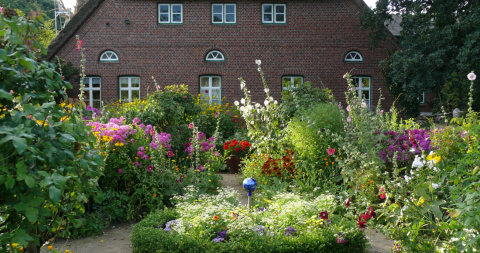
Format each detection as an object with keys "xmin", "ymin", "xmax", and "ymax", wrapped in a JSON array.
[{"xmin": 58, "ymin": 0, "xmax": 396, "ymax": 107}]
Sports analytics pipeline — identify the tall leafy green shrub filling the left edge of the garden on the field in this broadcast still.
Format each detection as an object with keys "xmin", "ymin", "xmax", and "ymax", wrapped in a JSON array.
[{"xmin": 0, "ymin": 9, "xmax": 104, "ymax": 252}]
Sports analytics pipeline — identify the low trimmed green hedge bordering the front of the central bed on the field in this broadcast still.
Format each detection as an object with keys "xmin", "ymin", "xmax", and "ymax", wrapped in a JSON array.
[{"xmin": 132, "ymin": 209, "xmax": 368, "ymax": 253}]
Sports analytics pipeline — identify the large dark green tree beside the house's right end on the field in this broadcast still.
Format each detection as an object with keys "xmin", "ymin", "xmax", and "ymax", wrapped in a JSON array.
[{"xmin": 360, "ymin": 0, "xmax": 480, "ymax": 117}]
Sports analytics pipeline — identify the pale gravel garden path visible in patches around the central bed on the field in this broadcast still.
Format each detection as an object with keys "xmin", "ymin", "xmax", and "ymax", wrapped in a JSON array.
[{"xmin": 41, "ymin": 174, "xmax": 393, "ymax": 253}]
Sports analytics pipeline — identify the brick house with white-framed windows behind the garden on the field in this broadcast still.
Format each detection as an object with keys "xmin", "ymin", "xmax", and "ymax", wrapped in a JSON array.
[{"xmin": 47, "ymin": 0, "xmax": 401, "ymax": 108}]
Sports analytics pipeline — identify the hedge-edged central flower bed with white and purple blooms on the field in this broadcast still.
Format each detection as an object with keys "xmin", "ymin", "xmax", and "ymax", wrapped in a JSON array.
[{"xmin": 132, "ymin": 186, "xmax": 367, "ymax": 252}]
